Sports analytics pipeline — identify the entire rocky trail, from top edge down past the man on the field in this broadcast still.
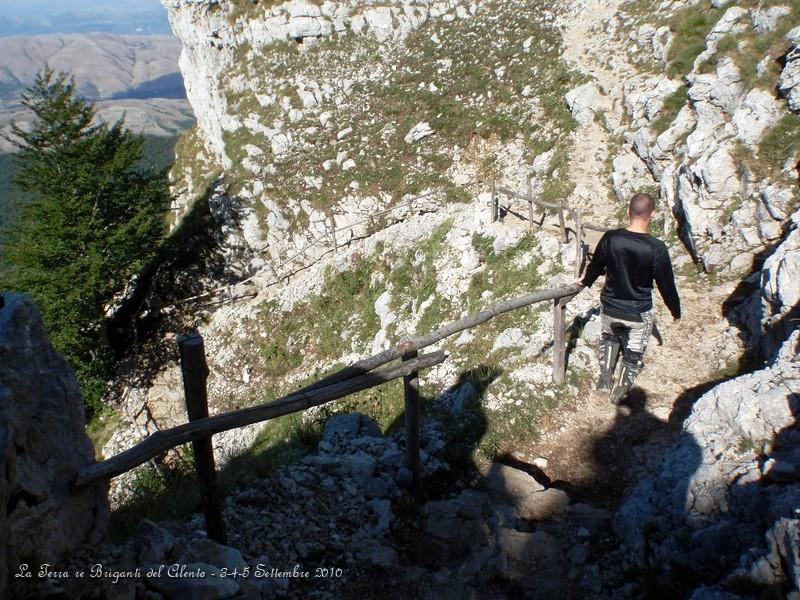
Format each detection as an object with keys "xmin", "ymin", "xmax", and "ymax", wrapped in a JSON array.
[{"xmin": 514, "ymin": 0, "xmax": 736, "ymax": 508}]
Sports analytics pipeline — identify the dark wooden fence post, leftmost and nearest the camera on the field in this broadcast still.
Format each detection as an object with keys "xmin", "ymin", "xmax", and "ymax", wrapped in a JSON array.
[{"xmin": 178, "ymin": 333, "xmax": 227, "ymax": 544}]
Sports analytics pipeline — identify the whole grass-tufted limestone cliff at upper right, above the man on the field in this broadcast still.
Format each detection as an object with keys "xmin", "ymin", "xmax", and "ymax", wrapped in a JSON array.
[{"xmin": 613, "ymin": 2, "xmax": 800, "ymax": 276}]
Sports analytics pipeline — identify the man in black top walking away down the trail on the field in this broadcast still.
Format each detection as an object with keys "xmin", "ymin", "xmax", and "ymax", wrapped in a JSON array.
[{"xmin": 579, "ymin": 194, "xmax": 681, "ymax": 404}]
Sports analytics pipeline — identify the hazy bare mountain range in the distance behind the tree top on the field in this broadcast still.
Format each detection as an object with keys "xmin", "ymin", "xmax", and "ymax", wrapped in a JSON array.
[{"xmin": 0, "ymin": 33, "xmax": 194, "ymax": 152}]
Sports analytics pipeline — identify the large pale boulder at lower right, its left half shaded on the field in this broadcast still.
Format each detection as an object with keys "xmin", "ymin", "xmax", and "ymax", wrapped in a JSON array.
[{"xmin": 614, "ymin": 332, "xmax": 800, "ymax": 586}]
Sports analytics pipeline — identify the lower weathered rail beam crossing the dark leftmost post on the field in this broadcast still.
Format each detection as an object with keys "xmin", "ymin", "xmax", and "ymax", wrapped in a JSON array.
[{"xmin": 74, "ymin": 350, "xmax": 447, "ymax": 487}]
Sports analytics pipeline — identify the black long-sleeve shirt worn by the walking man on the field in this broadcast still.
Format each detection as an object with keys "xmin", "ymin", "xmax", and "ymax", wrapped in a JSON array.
[{"xmin": 581, "ymin": 229, "xmax": 681, "ymax": 321}]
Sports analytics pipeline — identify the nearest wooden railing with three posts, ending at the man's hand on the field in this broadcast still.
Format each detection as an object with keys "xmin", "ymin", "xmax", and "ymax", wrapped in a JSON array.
[{"xmin": 74, "ymin": 284, "xmax": 580, "ymax": 543}]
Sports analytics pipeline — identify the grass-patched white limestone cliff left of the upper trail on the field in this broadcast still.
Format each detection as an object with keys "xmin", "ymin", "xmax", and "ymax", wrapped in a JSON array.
[{"xmin": 159, "ymin": 0, "xmax": 569, "ymax": 272}]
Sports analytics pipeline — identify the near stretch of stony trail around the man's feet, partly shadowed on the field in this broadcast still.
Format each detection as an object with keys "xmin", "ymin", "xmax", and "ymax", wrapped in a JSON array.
[{"xmin": 515, "ymin": 277, "xmax": 730, "ymax": 508}]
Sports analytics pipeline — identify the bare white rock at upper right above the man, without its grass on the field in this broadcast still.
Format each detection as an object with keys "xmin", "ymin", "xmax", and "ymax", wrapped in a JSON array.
[{"xmin": 612, "ymin": 6, "xmax": 800, "ymax": 274}]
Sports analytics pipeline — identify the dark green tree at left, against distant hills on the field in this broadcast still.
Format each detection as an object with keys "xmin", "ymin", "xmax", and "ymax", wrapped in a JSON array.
[{"xmin": 2, "ymin": 68, "xmax": 168, "ymax": 412}]
